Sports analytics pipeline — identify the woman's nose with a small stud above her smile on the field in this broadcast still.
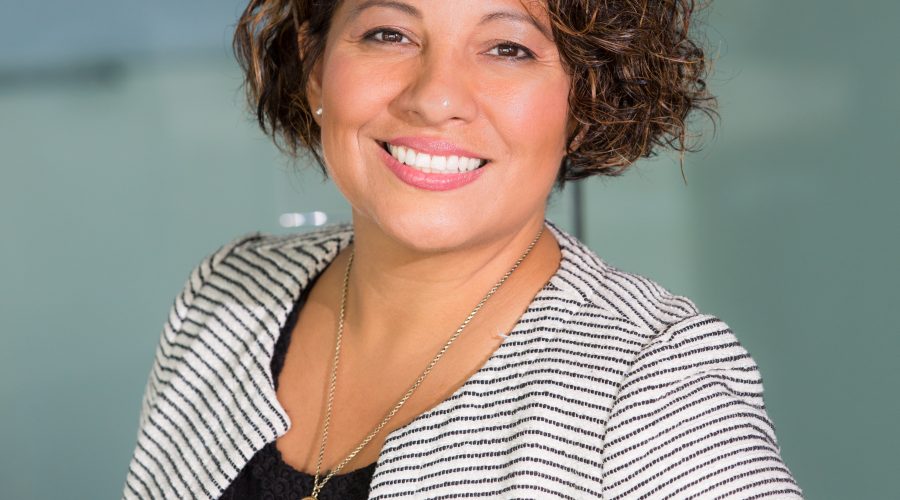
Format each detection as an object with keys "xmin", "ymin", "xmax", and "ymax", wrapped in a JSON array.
[{"xmin": 394, "ymin": 49, "xmax": 478, "ymax": 126}]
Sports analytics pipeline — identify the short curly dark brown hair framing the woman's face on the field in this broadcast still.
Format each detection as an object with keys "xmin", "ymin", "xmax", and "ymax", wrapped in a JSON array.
[{"xmin": 233, "ymin": 0, "xmax": 716, "ymax": 185}]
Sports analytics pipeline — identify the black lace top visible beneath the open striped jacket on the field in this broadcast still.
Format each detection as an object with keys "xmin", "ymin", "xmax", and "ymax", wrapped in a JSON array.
[{"xmin": 221, "ymin": 281, "xmax": 375, "ymax": 500}]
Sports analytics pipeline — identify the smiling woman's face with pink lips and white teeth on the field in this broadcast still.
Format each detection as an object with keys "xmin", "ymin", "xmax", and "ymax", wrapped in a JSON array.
[{"xmin": 308, "ymin": 0, "xmax": 569, "ymax": 251}]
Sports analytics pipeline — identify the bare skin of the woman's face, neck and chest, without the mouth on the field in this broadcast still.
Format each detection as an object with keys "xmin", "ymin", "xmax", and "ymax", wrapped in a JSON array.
[{"xmin": 277, "ymin": 0, "xmax": 569, "ymax": 476}]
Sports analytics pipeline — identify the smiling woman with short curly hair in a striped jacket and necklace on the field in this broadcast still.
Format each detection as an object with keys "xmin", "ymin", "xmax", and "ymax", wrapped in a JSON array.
[{"xmin": 125, "ymin": 0, "xmax": 801, "ymax": 499}]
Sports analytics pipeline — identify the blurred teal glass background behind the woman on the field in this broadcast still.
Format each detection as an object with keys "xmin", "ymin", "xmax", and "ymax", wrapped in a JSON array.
[{"xmin": 0, "ymin": 0, "xmax": 900, "ymax": 499}]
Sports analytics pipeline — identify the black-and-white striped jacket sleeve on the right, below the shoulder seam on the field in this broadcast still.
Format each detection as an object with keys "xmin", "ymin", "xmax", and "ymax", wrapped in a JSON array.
[{"xmin": 603, "ymin": 315, "xmax": 803, "ymax": 499}]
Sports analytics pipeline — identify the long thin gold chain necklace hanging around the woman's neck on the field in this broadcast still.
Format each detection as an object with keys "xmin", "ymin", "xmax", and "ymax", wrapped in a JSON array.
[{"xmin": 303, "ymin": 226, "xmax": 544, "ymax": 500}]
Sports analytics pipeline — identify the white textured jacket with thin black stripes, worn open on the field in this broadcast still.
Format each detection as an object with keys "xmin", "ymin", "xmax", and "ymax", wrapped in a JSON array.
[{"xmin": 124, "ymin": 222, "xmax": 802, "ymax": 499}]
